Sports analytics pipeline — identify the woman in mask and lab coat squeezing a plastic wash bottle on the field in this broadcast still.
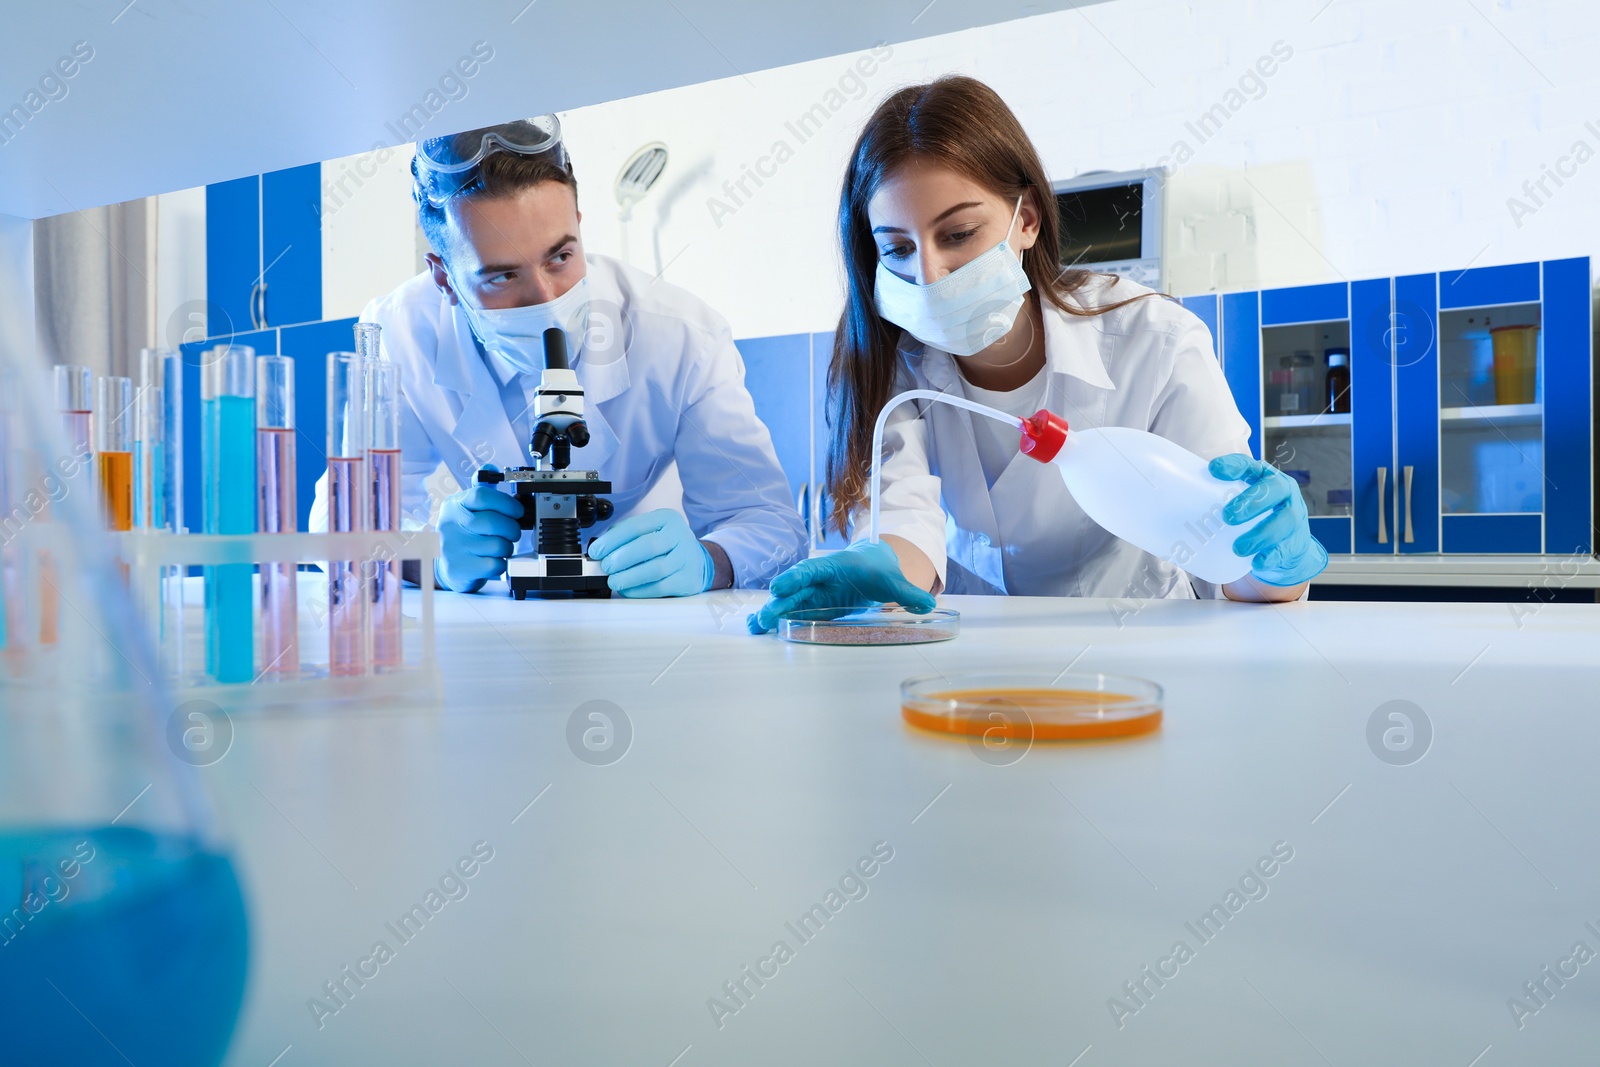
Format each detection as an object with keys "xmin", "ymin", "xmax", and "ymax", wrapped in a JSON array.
[{"xmin": 750, "ymin": 77, "xmax": 1328, "ymax": 632}]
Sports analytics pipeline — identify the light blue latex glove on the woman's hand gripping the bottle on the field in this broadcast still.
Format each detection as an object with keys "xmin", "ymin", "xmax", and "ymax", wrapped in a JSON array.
[{"xmin": 1211, "ymin": 453, "xmax": 1328, "ymax": 585}]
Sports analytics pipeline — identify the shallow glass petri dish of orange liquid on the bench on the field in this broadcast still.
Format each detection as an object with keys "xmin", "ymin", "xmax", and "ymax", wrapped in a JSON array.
[{"xmin": 901, "ymin": 672, "xmax": 1163, "ymax": 742}]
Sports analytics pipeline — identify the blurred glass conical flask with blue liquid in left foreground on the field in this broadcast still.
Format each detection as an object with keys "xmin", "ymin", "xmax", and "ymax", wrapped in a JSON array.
[{"xmin": 0, "ymin": 219, "xmax": 248, "ymax": 1065}]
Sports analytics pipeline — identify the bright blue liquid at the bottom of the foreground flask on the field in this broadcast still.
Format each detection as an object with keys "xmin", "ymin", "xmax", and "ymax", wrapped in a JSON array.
[{"xmin": 0, "ymin": 827, "xmax": 248, "ymax": 1067}]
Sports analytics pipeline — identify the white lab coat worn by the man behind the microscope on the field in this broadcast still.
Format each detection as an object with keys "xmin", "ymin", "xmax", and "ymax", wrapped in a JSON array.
[{"xmin": 309, "ymin": 256, "xmax": 806, "ymax": 587}]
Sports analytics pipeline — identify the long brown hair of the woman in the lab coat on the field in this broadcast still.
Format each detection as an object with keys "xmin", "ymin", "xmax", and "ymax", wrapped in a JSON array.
[{"xmin": 827, "ymin": 75, "xmax": 1144, "ymax": 533}]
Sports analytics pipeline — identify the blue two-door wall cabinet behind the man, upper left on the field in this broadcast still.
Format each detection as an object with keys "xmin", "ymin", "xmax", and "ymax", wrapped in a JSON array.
[{"xmin": 205, "ymin": 163, "xmax": 322, "ymax": 338}]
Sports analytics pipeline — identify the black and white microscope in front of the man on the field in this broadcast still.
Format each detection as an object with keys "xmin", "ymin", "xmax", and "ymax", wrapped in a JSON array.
[{"xmin": 475, "ymin": 326, "xmax": 613, "ymax": 600}]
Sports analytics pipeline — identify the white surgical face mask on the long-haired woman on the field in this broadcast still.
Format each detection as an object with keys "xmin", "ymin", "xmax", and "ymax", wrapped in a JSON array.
[{"xmin": 874, "ymin": 197, "xmax": 1032, "ymax": 363}]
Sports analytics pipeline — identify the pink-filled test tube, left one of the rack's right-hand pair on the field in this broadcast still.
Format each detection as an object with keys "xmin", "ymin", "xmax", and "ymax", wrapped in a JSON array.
[{"xmin": 328, "ymin": 352, "xmax": 370, "ymax": 675}]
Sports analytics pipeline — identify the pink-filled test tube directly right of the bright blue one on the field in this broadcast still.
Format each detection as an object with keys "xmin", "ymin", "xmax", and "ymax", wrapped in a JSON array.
[{"xmin": 256, "ymin": 355, "xmax": 299, "ymax": 678}]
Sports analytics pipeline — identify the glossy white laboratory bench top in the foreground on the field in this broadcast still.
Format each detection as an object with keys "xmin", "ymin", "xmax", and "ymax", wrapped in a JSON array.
[{"xmin": 216, "ymin": 592, "xmax": 1600, "ymax": 1067}]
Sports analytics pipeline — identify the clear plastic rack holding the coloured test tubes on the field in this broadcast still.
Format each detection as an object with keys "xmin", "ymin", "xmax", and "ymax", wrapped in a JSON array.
[{"xmin": 112, "ymin": 530, "xmax": 443, "ymax": 709}]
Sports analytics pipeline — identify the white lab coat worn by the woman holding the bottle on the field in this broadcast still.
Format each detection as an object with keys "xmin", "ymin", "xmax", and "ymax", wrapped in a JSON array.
[{"xmin": 853, "ymin": 275, "xmax": 1250, "ymax": 598}]
